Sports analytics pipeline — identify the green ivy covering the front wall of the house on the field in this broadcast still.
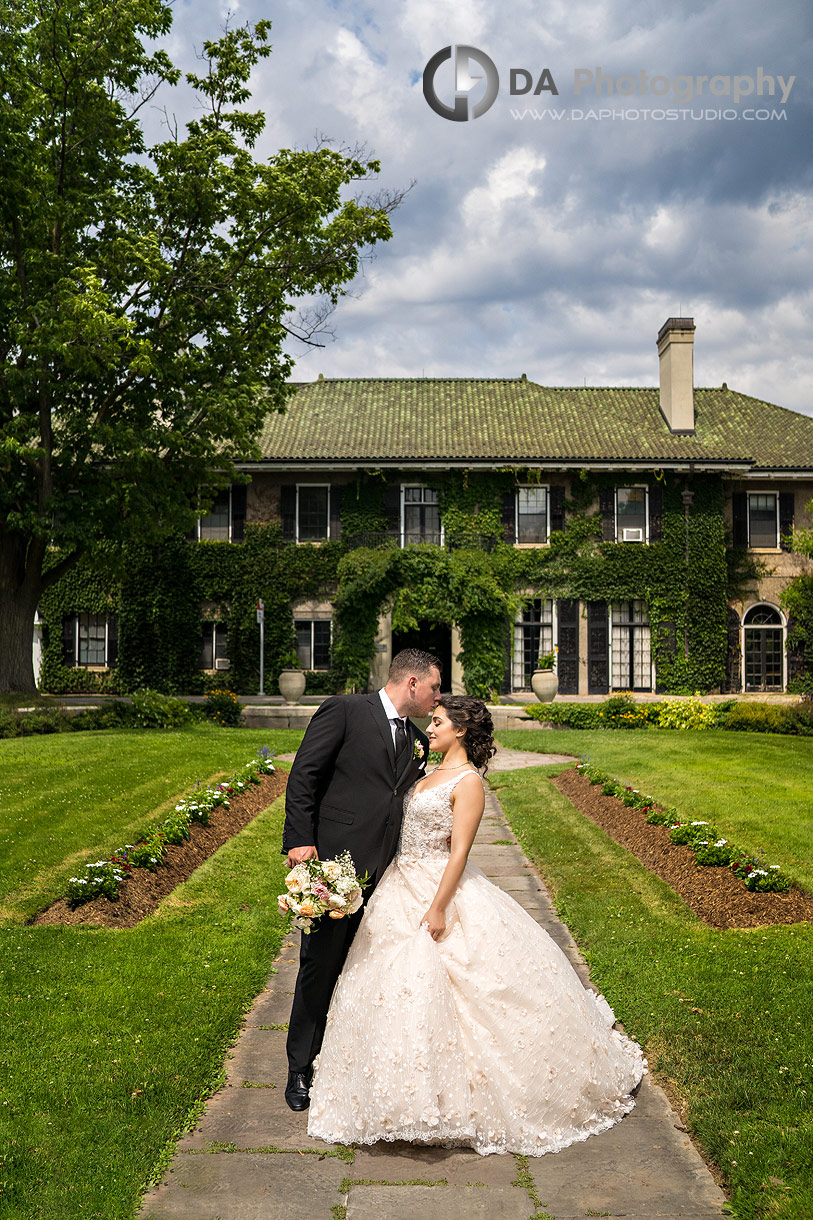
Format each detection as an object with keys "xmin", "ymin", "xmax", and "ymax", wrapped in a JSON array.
[{"xmin": 42, "ymin": 471, "xmax": 742, "ymax": 697}]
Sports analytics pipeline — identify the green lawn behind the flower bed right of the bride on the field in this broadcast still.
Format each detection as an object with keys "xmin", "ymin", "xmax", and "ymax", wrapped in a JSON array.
[{"xmin": 498, "ymin": 728, "xmax": 813, "ymax": 891}]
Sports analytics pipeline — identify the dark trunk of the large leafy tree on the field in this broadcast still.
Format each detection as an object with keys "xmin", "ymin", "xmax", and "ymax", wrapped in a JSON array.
[{"xmin": 0, "ymin": 534, "xmax": 42, "ymax": 694}]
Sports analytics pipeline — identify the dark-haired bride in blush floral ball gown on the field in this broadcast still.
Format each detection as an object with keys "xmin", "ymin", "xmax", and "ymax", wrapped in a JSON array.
[{"xmin": 308, "ymin": 695, "xmax": 646, "ymax": 1157}]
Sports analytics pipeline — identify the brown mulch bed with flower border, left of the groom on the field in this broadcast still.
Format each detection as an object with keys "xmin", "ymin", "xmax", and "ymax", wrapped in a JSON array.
[{"xmin": 29, "ymin": 771, "xmax": 288, "ymax": 927}]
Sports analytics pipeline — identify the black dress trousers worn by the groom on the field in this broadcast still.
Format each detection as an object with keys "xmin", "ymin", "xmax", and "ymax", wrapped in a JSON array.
[{"xmin": 287, "ymin": 891, "xmax": 361, "ymax": 1071}]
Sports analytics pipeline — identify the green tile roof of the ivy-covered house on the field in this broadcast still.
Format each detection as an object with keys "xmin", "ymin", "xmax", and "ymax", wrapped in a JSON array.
[{"xmin": 260, "ymin": 377, "xmax": 813, "ymax": 470}]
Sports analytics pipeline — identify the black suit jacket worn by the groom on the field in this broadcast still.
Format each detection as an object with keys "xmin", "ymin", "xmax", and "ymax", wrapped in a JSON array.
[{"xmin": 282, "ymin": 693, "xmax": 428, "ymax": 894}]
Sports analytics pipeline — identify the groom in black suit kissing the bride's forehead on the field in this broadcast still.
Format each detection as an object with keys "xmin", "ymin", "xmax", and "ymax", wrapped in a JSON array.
[{"xmin": 282, "ymin": 648, "xmax": 441, "ymax": 1110}]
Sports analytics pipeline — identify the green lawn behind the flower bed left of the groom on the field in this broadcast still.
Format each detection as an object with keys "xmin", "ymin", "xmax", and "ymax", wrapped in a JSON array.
[{"xmin": 0, "ymin": 725, "xmax": 302, "ymax": 924}]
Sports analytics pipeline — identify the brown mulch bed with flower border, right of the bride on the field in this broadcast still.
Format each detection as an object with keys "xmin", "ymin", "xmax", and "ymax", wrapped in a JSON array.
[{"xmin": 551, "ymin": 770, "xmax": 813, "ymax": 927}]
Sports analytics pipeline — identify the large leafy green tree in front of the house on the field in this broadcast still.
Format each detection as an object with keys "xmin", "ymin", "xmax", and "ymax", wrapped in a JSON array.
[{"xmin": 0, "ymin": 0, "xmax": 397, "ymax": 692}]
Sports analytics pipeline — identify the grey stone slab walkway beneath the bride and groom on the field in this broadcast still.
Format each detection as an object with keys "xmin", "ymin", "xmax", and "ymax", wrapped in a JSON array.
[{"xmin": 139, "ymin": 750, "xmax": 725, "ymax": 1220}]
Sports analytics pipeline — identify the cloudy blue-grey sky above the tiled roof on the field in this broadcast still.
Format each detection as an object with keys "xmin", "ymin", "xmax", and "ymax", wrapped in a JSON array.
[{"xmin": 155, "ymin": 0, "xmax": 813, "ymax": 415}]
